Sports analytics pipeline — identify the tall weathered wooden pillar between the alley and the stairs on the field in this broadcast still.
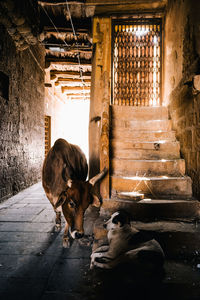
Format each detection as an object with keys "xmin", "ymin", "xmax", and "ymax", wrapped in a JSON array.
[{"xmin": 93, "ymin": 17, "xmax": 111, "ymax": 199}]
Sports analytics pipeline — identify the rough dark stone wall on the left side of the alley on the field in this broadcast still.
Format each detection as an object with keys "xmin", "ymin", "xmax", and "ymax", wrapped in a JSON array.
[{"xmin": 0, "ymin": 25, "xmax": 45, "ymax": 200}]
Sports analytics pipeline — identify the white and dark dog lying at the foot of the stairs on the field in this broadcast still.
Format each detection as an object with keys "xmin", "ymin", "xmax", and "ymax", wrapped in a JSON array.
[{"xmin": 90, "ymin": 211, "xmax": 165, "ymax": 269}]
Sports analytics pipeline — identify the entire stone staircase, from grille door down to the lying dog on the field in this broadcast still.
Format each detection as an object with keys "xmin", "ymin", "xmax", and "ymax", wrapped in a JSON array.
[{"xmin": 94, "ymin": 106, "xmax": 200, "ymax": 258}]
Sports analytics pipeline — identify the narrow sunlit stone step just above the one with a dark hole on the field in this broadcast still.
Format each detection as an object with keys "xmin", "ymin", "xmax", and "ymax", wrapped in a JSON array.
[{"xmin": 111, "ymin": 129, "xmax": 176, "ymax": 143}]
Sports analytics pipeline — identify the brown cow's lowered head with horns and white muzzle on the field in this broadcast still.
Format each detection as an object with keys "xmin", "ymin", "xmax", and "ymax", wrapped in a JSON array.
[{"xmin": 55, "ymin": 168, "xmax": 107, "ymax": 239}]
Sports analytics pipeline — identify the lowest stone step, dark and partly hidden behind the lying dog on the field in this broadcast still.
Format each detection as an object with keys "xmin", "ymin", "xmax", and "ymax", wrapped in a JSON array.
[{"xmin": 93, "ymin": 216, "xmax": 200, "ymax": 259}]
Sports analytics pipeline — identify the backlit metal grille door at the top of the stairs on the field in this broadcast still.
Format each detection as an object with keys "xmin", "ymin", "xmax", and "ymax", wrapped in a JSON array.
[{"xmin": 112, "ymin": 19, "xmax": 162, "ymax": 106}]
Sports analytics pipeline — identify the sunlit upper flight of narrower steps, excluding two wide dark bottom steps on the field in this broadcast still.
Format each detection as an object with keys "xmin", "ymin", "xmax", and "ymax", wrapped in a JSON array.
[{"xmin": 111, "ymin": 106, "xmax": 192, "ymax": 199}]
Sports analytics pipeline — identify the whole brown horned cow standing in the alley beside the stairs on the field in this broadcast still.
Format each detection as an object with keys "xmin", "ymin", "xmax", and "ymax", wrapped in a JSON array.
[{"xmin": 42, "ymin": 139, "xmax": 107, "ymax": 248}]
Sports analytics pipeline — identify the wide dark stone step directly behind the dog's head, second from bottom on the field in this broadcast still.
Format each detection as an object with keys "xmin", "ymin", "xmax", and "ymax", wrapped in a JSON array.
[{"xmin": 101, "ymin": 195, "xmax": 200, "ymax": 221}]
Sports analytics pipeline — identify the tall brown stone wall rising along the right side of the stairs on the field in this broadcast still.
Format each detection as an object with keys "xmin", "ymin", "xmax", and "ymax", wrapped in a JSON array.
[{"xmin": 164, "ymin": 0, "xmax": 200, "ymax": 197}]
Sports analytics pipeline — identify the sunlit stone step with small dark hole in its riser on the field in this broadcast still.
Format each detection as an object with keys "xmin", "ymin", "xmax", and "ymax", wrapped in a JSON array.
[{"xmin": 111, "ymin": 139, "xmax": 180, "ymax": 159}]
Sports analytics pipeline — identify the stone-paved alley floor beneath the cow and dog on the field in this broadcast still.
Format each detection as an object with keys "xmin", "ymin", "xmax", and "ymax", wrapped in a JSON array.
[{"xmin": 0, "ymin": 183, "xmax": 200, "ymax": 300}]
